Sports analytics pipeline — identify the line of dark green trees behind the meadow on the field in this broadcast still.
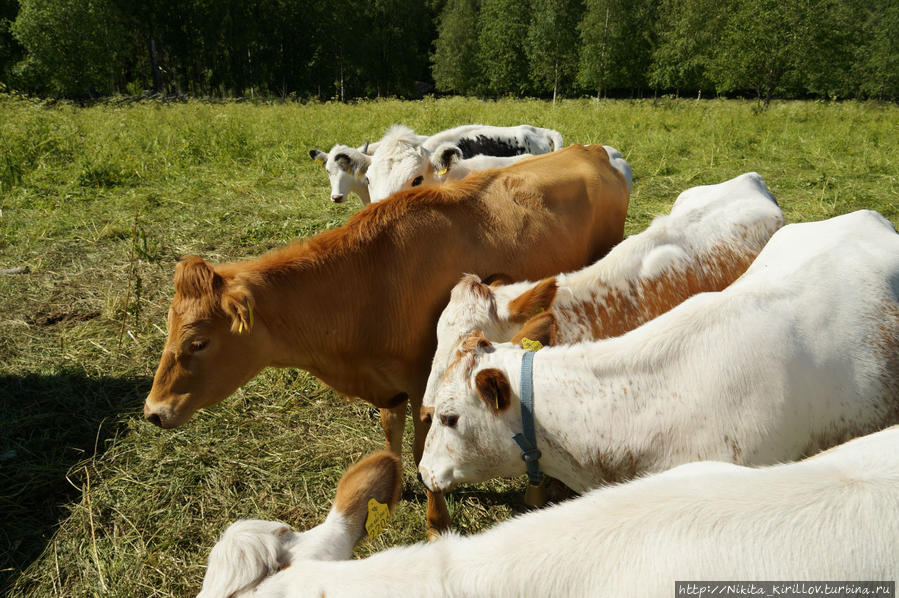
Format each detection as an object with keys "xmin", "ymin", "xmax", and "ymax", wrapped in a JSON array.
[{"xmin": 0, "ymin": 0, "xmax": 899, "ymax": 101}]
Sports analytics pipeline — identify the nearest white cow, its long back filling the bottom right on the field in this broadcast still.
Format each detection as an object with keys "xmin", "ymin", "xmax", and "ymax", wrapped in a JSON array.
[{"xmin": 201, "ymin": 427, "xmax": 899, "ymax": 598}]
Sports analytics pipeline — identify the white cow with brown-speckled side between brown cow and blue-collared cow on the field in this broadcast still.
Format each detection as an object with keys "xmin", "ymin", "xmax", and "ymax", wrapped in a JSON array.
[{"xmin": 423, "ymin": 173, "xmax": 784, "ymax": 416}]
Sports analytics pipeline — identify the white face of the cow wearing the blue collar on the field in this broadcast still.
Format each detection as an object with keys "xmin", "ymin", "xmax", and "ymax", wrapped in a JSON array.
[{"xmin": 418, "ymin": 331, "xmax": 525, "ymax": 492}]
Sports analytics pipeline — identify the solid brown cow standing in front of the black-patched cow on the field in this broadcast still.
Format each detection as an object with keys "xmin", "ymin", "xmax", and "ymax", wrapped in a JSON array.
[{"xmin": 144, "ymin": 145, "xmax": 628, "ymax": 530}]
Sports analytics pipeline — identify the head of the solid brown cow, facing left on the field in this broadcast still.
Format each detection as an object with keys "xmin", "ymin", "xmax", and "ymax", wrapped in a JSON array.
[{"xmin": 144, "ymin": 257, "xmax": 267, "ymax": 428}]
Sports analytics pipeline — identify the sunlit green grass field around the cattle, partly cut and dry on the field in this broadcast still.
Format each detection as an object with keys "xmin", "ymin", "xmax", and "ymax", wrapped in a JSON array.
[{"xmin": 0, "ymin": 96, "xmax": 899, "ymax": 597}]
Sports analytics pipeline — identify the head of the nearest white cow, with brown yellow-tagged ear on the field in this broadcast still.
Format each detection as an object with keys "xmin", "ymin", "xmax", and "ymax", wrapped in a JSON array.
[{"xmin": 198, "ymin": 452, "xmax": 402, "ymax": 598}]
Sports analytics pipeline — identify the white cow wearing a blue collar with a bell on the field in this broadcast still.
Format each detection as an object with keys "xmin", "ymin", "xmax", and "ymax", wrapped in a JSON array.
[{"xmin": 419, "ymin": 211, "xmax": 899, "ymax": 492}]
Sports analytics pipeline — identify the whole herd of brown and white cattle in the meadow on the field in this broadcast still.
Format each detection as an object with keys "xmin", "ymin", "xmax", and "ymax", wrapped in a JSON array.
[{"xmin": 135, "ymin": 125, "xmax": 899, "ymax": 598}]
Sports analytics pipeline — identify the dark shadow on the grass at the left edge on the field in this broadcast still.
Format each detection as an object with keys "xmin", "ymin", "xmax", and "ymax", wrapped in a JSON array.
[{"xmin": 0, "ymin": 371, "xmax": 152, "ymax": 590}]
